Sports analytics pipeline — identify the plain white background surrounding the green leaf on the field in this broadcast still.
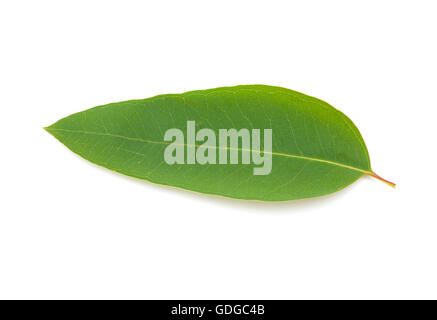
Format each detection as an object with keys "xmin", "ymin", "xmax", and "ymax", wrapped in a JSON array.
[{"xmin": 0, "ymin": 0, "xmax": 437, "ymax": 299}]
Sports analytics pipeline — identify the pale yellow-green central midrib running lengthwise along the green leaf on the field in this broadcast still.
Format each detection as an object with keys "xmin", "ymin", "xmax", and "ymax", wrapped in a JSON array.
[{"xmin": 46, "ymin": 127, "xmax": 372, "ymax": 175}]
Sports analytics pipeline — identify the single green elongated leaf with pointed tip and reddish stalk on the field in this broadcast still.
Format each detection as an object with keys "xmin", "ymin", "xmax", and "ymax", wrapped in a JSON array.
[{"xmin": 45, "ymin": 85, "xmax": 394, "ymax": 201}]
